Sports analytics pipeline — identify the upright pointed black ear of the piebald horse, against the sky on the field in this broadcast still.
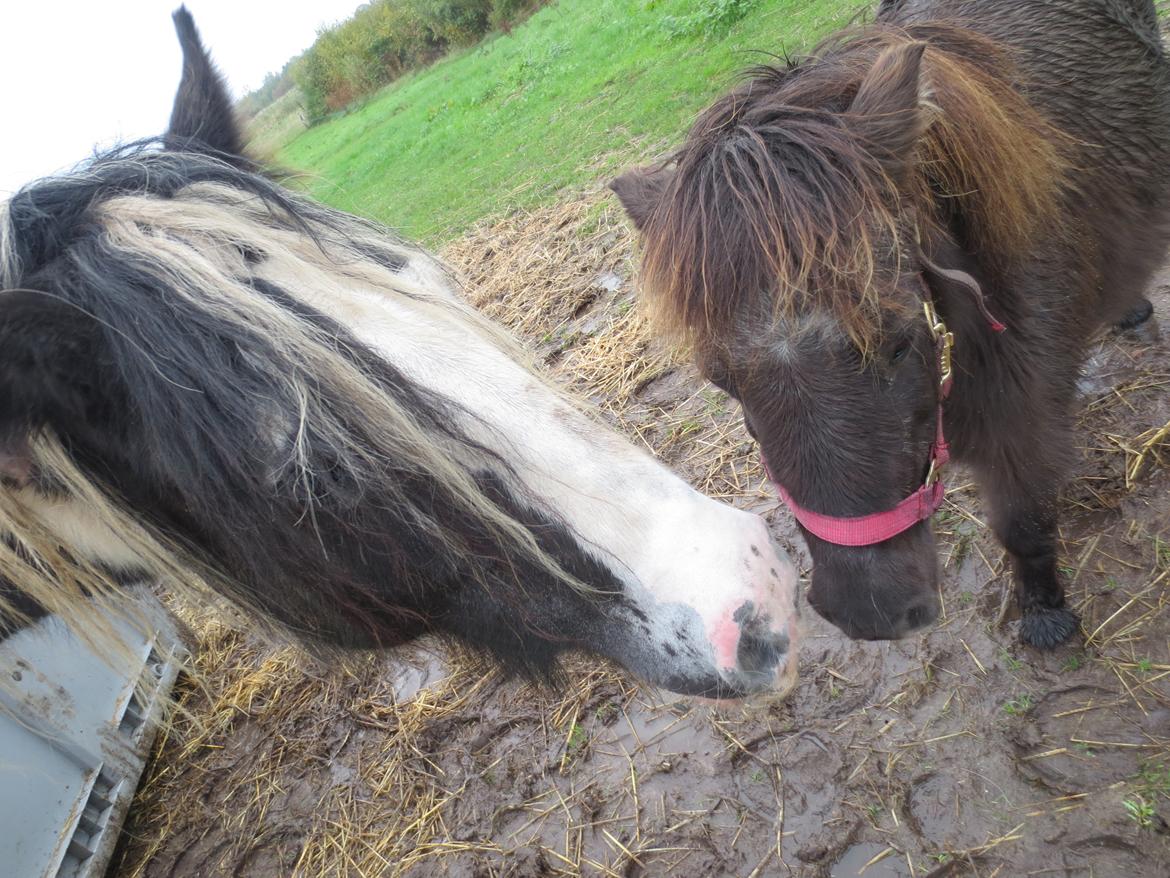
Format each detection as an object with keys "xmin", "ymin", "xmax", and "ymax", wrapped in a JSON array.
[{"xmin": 164, "ymin": 6, "xmax": 243, "ymax": 159}]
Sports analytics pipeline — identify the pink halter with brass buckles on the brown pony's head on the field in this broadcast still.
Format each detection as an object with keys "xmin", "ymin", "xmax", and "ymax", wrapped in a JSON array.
[{"xmin": 764, "ymin": 264, "xmax": 1006, "ymax": 547}]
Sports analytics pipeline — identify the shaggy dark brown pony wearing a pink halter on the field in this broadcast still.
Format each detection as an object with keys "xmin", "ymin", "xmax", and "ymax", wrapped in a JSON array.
[{"xmin": 612, "ymin": 0, "xmax": 1170, "ymax": 647}]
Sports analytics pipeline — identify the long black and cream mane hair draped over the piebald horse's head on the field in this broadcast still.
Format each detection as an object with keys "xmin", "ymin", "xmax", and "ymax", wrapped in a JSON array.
[{"xmin": 0, "ymin": 144, "xmax": 596, "ymax": 665}]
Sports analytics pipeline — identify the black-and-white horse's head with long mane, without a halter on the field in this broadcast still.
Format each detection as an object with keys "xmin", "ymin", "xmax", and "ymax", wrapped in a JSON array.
[{"xmin": 0, "ymin": 9, "xmax": 796, "ymax": 697}]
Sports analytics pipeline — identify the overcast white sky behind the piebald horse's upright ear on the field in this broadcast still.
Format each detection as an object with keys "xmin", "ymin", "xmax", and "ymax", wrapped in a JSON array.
[{"xmin": 0, "ymin": 0, "xmax": 360, "ymax": 197}]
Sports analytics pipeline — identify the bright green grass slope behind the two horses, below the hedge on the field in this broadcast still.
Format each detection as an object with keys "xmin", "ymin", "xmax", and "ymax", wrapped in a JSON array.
[{"xmin": 278, "ymin": 0, "xmax": 872, "ymax": 245}]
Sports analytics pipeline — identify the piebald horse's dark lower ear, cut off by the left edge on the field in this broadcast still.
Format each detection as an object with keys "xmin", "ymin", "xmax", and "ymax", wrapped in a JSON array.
[{"xmin": 0, "ymin": 290, "xmax": 101, "ymax": 483}]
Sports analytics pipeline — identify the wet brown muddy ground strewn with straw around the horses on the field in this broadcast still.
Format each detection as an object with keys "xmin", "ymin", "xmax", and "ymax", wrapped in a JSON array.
[{"xmin": 112, "ymin": 194, "xmax": 1170, "ymax": 878}]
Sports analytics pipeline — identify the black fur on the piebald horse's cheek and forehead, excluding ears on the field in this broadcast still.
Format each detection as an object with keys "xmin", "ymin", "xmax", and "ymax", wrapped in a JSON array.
[{"xmin": 0, "ymin": 168, "xmax": 641, "ymax": 671}]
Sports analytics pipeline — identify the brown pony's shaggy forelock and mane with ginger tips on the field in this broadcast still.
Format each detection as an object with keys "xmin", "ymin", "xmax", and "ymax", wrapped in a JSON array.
[{"xmin": 642, "ymin": 22, "xmax": 1073, "ymax": 350}]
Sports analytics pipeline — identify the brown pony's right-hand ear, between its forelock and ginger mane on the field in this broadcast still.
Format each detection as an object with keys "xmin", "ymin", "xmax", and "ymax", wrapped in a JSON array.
[{"xmin": 848, "ymin": 42, "xmax": 929, "ymax": 181}]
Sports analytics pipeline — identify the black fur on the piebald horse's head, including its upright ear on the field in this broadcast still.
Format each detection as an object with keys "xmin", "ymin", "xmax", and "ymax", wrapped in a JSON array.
[{"xmin": 0, "ymin": 9, "xmax": 659, "ymax": 694}]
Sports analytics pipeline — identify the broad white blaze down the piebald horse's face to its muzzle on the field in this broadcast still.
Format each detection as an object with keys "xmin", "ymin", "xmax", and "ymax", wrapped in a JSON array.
[{"xmin": 257, "ymin": 224, "xmax": 796, "ymax": 688}]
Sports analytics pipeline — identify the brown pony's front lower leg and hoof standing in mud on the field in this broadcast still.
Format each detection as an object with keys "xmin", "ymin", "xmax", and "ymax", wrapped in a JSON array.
[{"xmin": 979, "ymin": 441, "xmax": 1080, "ymax": 650}]
